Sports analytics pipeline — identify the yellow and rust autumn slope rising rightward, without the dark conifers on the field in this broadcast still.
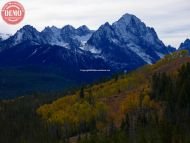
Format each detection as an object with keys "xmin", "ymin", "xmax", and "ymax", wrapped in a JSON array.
[{"xmin": 37, "ymin": 51, "xmax": 190, "ymax": 142}]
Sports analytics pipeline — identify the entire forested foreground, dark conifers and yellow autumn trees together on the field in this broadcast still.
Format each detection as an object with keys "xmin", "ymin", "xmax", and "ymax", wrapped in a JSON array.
[{"xmin": 0, "ymin": 51, "xmax": 190, "ymax": 143}]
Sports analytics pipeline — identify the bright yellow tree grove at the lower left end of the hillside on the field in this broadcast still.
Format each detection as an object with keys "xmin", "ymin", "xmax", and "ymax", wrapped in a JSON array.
[{"xmin": 37, "ymin": 92, "xmax": 107, "ymax": 126}]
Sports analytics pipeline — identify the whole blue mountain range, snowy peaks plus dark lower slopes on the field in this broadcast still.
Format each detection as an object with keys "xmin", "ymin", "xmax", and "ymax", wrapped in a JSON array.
[{"xmin": 0, "ymin": 14, "xmax": 177, "ymax": 98}]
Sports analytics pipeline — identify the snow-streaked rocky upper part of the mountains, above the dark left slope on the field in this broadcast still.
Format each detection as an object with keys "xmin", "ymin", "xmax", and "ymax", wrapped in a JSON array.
[{"xmin": 0, "ymin": 14, "xmax": 176, "ymax": 71}]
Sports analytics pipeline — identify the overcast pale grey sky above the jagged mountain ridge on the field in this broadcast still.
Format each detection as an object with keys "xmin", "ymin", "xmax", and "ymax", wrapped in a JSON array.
[{"xmin": 0, "ymin": 0, "xmax": 190, "ymax": 47}]
